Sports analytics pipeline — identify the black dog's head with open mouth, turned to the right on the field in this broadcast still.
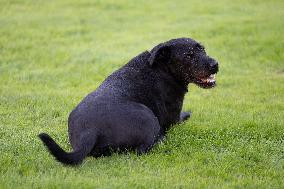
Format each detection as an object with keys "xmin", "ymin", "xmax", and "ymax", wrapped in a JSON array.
[{"xmin": 149, "ymin": 38, "xmax": 219, "ymax": 88}]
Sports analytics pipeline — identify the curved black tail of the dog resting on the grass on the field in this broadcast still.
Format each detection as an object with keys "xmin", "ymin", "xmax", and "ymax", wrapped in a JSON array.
[{"xmin": 38, "ymin": 133, "xmax": 95, "ymax": 165}]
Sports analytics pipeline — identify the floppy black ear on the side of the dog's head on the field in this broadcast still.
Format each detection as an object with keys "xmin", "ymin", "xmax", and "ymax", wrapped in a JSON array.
[{"xmin": 148, "ymin": 44, "xmax": 171, "ymax": 66}]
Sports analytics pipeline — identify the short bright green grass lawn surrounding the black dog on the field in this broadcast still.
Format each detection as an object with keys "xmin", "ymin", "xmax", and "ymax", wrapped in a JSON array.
[{"xmin": 0, "ymin": 0, "xmax": 284, "ymax": 188}]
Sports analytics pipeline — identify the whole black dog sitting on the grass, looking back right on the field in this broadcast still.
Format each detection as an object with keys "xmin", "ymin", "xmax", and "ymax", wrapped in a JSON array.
[{"xmin": 39, "ymin": 38, "xmax": 218, "ymax": 165}]
